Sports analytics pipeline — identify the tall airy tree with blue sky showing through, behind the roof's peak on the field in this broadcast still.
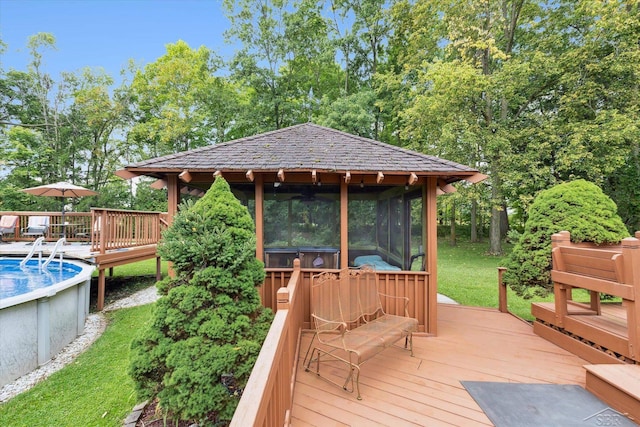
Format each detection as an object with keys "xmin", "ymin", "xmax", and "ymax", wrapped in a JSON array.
[{"xmin": 225, "ymin": 0, "xmax": 342, "ymax": 133}]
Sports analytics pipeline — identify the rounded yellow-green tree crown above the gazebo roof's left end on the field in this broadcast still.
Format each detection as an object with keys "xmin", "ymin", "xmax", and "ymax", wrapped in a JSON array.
[{"xmin": 129, "ymin": 41, "xmax": 234, "ymax": 157}]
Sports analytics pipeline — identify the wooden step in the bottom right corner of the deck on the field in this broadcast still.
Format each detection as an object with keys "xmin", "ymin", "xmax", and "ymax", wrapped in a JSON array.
[{"xmin": 585, "ymin": 364, "xmax": 640, "ymax": 423}]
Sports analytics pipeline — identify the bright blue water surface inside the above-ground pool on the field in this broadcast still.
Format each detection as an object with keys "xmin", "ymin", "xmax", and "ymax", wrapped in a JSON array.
[{"xmin": 0, "ymin": 258, "xmax": 82, "ymax": 300}]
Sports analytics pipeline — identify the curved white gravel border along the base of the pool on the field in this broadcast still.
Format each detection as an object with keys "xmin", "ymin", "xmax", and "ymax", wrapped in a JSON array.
[{"xmin": 0, "ymin": 285, "xmax": 158, "ymax": 403}]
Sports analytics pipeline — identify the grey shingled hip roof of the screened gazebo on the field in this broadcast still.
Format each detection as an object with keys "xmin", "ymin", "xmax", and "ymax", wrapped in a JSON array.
[{"xmin": 120, "ymin": 123, "xmax": 477, "ymax": 180}]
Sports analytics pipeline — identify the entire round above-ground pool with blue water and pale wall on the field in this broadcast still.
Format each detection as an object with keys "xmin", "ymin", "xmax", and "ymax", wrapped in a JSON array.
[{"xmin": 0, "ymin": 257, "xmax": 95, "ymax": 387}]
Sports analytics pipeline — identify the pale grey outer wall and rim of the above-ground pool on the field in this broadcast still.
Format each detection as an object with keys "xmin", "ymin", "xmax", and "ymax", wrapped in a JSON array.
[{"xmin": 0, "ymin": 260, "xmax": 95, "ymax": 387}]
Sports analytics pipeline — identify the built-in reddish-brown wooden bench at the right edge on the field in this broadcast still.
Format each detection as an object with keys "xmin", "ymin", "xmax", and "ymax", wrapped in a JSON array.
[{"xmin": 551, "ymin": 231, "xmax": 640, "ymax": 361}]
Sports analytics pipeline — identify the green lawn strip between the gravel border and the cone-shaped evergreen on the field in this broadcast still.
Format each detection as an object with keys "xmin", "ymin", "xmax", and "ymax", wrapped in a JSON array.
[{"xmin": 0, "ymin": 305, "xmax": 152, "ymax": 427}]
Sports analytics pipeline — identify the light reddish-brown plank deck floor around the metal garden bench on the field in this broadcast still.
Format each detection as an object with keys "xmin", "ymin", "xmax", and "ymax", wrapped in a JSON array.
[{"xmin": 291, "ymin": 304, "xmax": 588, "ymax": 427}]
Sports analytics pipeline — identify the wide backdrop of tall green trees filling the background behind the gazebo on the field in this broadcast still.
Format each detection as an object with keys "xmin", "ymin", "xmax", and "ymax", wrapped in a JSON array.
[{"xmin": 0, "ymin": 0, "xmax": 640, "ymax": 241}]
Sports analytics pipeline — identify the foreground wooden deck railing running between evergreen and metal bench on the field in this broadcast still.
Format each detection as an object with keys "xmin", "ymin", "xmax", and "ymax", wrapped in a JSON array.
[{"xmin": 231, "ymin": 259, "xmax": 304, "ymax": 427}]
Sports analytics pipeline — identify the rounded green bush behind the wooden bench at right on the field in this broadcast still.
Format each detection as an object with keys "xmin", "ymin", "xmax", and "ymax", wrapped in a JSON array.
[{"xmin": 504, "ymin": 179, "xmax": 629, "ymax": 297}]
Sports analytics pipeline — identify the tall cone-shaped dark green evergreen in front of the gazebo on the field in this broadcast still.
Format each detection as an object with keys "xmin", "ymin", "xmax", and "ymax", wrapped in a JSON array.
[{"xmin": 130, "ymin": 178, "xmax": 273, "ymax": 425}]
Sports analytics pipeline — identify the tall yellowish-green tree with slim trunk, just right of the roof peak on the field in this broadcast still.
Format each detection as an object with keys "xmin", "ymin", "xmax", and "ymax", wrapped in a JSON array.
[{"xmin": 396, "ymin": 0, "xmax": 533, "ymax": 254}]
